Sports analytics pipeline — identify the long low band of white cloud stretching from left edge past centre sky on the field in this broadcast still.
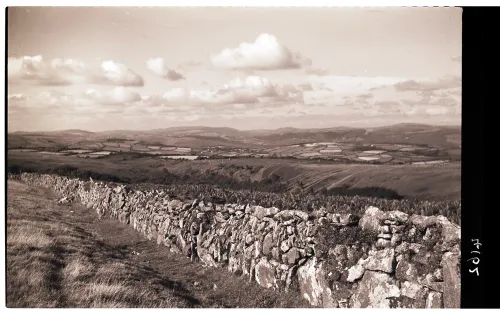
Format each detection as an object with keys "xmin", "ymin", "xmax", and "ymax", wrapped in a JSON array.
[{"xmin": 8, "ymin": 76, "xmax": 303, "ymax": 120}]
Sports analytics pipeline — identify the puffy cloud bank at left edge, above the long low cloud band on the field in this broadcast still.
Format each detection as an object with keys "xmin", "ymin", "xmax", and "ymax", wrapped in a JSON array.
[{"xmin": 7, "ymin": 55, "xmax": 144, "ymax": 86}]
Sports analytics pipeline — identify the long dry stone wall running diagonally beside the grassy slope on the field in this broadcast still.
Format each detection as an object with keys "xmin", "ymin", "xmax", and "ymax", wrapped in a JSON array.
[{"xmin": 13, "ymin": 173, "xmax": 460, "ymax": 308}]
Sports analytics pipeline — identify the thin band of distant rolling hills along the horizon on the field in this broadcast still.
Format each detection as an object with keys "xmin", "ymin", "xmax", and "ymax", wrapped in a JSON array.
[{"xmin": 8, "ymin": 123, "xmax": 461, "ymax": 148}]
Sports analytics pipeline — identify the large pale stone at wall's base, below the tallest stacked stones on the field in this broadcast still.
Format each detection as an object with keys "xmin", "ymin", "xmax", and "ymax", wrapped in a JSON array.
[{"xmin": 351, "ymin": 271, "xmax": 401, "ymax": 308}]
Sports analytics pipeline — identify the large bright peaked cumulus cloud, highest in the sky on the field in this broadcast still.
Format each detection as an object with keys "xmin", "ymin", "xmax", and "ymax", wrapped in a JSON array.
[{"xmin": 210, "ymin": 33, "xmax": 311, "ymax": 70}]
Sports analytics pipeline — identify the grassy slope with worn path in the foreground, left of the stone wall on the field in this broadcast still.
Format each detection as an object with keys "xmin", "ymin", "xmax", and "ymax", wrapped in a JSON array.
[{"xmin": 7, "ymin": 181, "xmax": 307, "ymax": 308}]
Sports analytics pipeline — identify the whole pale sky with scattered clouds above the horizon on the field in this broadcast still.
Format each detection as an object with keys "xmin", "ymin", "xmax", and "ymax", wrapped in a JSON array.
[{"xmin": 7, "ymin": 7, "xmax": 462, "ymax": 132}]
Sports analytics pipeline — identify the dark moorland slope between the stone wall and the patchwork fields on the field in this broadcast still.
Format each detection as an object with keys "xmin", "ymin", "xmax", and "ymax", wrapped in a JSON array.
[{"xmin": 8, "ymin": 152, "xmax": 461, "ymax": 199}]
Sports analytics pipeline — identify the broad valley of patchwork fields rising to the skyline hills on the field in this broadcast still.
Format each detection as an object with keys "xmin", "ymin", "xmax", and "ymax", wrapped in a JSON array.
[{"xmin": 8, "ymin": 124, "xmax": 461, "ymax": 164}]
